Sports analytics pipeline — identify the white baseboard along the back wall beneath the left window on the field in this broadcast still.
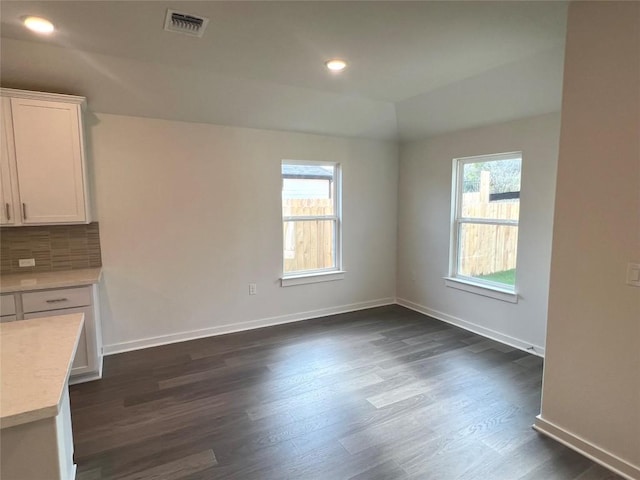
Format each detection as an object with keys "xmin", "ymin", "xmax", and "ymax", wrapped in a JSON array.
[{"xmin": 102, "ymin": 298, "xmax": 396, "ymax": 355}]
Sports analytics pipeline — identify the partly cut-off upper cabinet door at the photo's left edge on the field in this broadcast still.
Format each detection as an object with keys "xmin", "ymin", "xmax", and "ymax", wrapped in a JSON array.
[{"xmin": 0, "ymin": 97, "xmax": 17, "ymax": 225}]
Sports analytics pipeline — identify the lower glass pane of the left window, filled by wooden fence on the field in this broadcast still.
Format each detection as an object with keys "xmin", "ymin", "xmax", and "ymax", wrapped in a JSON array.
[{"xmin": 283, "ymin": 220, "xmax": 335, "ymax": 273}]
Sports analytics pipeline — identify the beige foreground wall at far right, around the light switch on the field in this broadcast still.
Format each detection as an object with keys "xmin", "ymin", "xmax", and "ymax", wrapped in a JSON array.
[{"xmin": 537, "ymin": 2, "xmax": 640, "ymax": 478}]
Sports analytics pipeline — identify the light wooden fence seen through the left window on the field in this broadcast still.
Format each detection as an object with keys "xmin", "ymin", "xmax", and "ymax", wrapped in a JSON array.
[{"xmin": 283, "ymin": 198, "xmax": 334, "ymax": 273}]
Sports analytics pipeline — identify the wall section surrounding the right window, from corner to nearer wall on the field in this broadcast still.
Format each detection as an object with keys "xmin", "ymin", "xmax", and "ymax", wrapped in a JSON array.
[{"xmin": 397, "ymin": 113, "xmax": 560, "ymax": 354}]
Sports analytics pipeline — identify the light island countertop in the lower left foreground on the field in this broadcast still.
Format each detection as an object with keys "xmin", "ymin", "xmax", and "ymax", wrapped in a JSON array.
[{"xmin": 0, "ymin": 313, "xmax": 84, "ymax": 428}]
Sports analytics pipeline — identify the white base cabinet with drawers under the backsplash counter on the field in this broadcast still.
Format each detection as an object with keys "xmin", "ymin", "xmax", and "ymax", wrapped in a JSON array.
[{"xmin": 0, "ymin": 285, "xmax": 102, "ymax": 384}]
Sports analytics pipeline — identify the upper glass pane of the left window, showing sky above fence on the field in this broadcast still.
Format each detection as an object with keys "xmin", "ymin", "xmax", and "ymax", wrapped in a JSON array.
[{"xmin": 282, "ymin": 164, "xmax": 335, "ymax": 217}]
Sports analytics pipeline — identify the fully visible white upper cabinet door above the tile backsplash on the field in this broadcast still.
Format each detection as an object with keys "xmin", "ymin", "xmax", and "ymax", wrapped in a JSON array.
[{"xmin": 11, "ymin": 98, "xmax": 87, "ymax": 224}]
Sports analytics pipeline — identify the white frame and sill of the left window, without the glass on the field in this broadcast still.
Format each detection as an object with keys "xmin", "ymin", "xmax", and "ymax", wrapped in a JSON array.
[{"xmin": 280, "ymin": 159, "xmax": 345, "ymax": 287}]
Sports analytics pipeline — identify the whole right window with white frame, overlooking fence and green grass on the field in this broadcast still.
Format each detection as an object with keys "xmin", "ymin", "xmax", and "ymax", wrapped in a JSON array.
[{"xmin": 449, "ymin": 152, "xmax": 522, "ymax": 299}]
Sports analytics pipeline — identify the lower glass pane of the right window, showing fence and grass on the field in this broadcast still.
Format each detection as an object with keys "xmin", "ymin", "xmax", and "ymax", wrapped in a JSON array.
[{"xmin": 457, "ymin": 223, "xmax": 518, "ymax": 287}]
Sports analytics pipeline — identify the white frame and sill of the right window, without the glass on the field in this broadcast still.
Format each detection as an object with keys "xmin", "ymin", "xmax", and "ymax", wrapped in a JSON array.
[{"xmin": 444, "ymin": 151, "xmax": 523, "ymax": 303}]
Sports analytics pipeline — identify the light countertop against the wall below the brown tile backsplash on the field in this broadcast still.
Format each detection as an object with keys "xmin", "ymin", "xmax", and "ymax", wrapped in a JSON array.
[{"xmin": 0, "ymin": 268, "xmax": 102, "ymax": 293}]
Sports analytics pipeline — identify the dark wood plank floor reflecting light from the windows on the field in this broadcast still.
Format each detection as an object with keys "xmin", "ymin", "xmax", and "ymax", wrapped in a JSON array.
[{"xmin": 71, "ymin": 306, "xmax": 619, "ymax": 480}]
